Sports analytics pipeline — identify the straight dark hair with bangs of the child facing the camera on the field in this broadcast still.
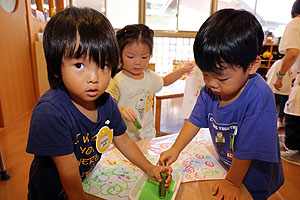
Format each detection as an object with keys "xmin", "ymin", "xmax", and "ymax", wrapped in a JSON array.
[{"xmin": 43, "ymin": 7, "xmax": 119, "ymax": 89}]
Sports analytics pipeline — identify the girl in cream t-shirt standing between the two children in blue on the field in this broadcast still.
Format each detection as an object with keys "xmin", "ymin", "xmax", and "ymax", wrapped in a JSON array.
[{"xmin": 107, "ymin": 24, "xmax": 195, "ymax": 141}]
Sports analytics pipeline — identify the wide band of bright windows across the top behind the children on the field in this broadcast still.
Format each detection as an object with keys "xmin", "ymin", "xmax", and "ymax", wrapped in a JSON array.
[{"xmin": 68, "ymin": 0, "xmax": 295, "ymax": 37}]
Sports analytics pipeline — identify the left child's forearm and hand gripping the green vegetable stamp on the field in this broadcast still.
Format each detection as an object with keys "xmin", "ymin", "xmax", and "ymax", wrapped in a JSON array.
[{"xmin": 113, "ymin": 133, "xmax": 172, "ymax": 187}]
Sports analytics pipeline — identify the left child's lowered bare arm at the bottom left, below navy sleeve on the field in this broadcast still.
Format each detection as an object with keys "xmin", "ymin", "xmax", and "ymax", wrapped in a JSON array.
[{"xmin": 52, "ymin": 153, "xmax": 88, "ymax": 200}]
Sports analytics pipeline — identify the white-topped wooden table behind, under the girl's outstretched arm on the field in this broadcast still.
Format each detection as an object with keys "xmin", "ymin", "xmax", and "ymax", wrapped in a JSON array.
[{"xmin": 155, "ymin": 80, "xmax": 185, "ymax": 137}]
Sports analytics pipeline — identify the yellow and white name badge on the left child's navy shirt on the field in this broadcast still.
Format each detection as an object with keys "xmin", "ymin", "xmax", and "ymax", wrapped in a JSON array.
[{"xmin": 96, "ymin": 126, "xmax": 113, "ymax": 153}]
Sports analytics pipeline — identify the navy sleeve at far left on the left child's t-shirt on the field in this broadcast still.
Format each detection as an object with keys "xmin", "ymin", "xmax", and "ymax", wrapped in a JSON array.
[{"xmin": 26, "ymin": 102, "xmax": 74, "ymax": 156}]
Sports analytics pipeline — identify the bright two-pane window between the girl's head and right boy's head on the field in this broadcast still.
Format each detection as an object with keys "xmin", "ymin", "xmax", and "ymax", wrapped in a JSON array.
[{"xmin": 145, "ymin": 0, "xmax": 211, "ymax": 31}]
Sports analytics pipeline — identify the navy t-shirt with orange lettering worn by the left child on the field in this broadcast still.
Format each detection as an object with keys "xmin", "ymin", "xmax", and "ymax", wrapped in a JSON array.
[{"xmin": 26, "ymin": 89, "xmax": 126, "ymax": 200}]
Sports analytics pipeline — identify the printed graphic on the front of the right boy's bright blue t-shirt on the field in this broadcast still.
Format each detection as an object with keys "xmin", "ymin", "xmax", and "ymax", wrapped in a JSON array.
[{"xmin": 208, "ymin": 113, "xmax": 237, "ymax": 165}]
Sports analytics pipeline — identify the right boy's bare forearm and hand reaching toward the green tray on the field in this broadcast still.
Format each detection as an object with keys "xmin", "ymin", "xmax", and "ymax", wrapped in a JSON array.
[{"xmin": 159, "ymin": 121, "xmax": 200, "ymax": 166}]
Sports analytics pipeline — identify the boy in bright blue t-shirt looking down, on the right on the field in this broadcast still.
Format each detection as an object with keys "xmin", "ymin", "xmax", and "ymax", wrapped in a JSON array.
[{"xmin": 159, "ymin": 9, "xmax": 284, "ymax": 200}]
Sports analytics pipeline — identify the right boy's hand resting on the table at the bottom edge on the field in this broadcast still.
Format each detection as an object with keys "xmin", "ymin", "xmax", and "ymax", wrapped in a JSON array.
[{"xmin": 212, "ymin": 179, "xmax": 241, "ymax": 200}]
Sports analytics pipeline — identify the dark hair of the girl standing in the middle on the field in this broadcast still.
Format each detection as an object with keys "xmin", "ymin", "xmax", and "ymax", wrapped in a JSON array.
[{"xmin": 117, "ymin": 24, "xmax": 154, "ymax": 61}]
